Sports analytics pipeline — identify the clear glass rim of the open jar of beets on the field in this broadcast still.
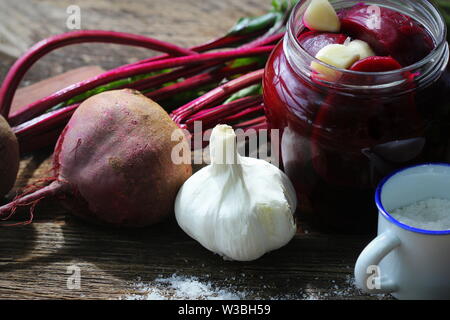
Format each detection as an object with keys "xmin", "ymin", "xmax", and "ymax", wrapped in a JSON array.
[{"xmin": 285, "ymin": 0, "xmax": 447, "ymax": 78}]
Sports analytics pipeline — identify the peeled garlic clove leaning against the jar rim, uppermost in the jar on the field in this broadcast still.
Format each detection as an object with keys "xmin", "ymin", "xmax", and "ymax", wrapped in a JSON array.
[{"xmin": 303, "ymin": 0, "xmax": 341, "ymax": 32}]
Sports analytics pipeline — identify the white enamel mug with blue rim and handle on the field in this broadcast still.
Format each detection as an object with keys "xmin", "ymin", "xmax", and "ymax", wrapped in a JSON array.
[{"xmin": 355, "ymin": 164, "xmax": 450, "ymax": 300}]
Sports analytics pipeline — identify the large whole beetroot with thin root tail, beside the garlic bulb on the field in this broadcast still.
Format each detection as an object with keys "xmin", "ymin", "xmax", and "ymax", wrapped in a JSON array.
[{"xmin": 0, "ymin": 89, "xmax": 192, "ymax": 227}]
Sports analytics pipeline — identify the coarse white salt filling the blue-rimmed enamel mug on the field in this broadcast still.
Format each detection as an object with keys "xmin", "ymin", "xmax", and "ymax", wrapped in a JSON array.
[{"xmin": 390, "ymin": 198, "xmax": 450, "ymax": 231}]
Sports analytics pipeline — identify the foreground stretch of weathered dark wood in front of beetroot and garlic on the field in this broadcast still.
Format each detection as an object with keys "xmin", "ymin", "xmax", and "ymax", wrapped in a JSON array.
[{"xmin": 0, "ymin": 217, "xmax": 384, "ymax": 299}]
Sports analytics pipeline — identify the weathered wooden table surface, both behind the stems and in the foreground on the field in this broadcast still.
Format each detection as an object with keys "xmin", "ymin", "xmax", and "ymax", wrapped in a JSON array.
[{"xmin": 0, "ymin": 0, "xmax": 389, "ymax": 299}]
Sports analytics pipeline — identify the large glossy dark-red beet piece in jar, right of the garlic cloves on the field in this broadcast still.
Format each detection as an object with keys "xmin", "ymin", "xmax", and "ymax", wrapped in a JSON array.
[{"xmin": 339, "ymin": 5, "xmax": 434, "ymax": 66}]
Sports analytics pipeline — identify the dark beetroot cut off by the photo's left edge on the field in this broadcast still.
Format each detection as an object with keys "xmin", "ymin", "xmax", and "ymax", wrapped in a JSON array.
[{"xmin": 0, "ymin": 116, "xmax": 19, "ymax": 197}]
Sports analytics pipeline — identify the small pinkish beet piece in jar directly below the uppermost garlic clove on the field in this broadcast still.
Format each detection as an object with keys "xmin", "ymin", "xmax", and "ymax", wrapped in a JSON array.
[{"xmin": 298, "ymin": 31, "xmax": 347, "ymax": 57}]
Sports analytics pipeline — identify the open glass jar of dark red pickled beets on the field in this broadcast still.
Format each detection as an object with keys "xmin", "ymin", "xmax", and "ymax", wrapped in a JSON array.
[{"xmin": 263, "ymin": 0, "xmax": 450, "ymax": 234}]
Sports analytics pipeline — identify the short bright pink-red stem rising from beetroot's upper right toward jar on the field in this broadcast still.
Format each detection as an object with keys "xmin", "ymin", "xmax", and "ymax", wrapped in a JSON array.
[{"xmin": 172, "ymin": 69, "xmax": 264, "ymax": 123}]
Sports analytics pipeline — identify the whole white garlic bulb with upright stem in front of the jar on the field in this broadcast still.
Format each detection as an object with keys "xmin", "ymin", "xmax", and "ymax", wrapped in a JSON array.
[{"xmin": 175, "ymin": 125, "xmax": 297, "ymax": 261}]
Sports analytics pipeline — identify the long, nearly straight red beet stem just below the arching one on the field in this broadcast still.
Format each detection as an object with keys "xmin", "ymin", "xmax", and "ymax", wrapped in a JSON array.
[{"xmin": 9, "ymin": 46, "xmax": 274, "ymax": 125}]
